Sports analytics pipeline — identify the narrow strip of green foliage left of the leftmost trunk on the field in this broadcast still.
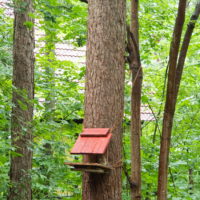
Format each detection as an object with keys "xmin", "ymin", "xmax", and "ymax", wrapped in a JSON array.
[{"xmin": 0, "ymin": 8, "xmax": 12, "ymax": 198}]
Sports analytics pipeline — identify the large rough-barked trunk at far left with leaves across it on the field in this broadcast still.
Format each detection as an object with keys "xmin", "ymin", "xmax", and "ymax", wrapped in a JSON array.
[{"xmin": 8, "ymin": 0, "xmax": 34, "ymax": 200}]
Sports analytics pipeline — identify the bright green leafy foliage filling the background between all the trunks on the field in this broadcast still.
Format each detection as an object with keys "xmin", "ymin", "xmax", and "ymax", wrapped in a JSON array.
[{"xmin": 0, "ymin": 0, "xmax": 200, "ymax": 200}]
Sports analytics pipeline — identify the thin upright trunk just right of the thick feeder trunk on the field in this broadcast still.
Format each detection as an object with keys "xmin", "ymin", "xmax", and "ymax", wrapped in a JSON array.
[{"xmin": 130, "ymin": 0, "xmax": 142, "ymax": 200}]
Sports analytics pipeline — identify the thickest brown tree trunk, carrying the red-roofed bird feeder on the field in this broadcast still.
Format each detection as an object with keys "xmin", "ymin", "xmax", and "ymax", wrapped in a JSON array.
[{"xmin": 83, "ymin": 0, "xmax": 125, "ymax": 200}]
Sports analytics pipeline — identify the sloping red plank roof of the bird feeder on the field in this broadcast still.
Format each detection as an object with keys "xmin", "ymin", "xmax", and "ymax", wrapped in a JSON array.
[{"xmin": 71, "ymin": 128, "xmax": 112, "ymax": 154}]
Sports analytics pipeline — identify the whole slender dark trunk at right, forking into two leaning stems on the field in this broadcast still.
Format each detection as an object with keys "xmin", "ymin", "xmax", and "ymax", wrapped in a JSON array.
[{"xmin": 158, "ymin": 0, "xmax": 200, "ymax": 200}]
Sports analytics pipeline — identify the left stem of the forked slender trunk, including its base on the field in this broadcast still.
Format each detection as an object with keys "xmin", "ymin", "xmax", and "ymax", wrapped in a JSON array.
[{"xmin": 157, "ymin": 0, "xmax": 187, "ymax": 200}]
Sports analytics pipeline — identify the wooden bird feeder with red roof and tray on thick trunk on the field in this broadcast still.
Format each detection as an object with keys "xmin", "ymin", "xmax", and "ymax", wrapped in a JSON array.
[{"xmin": 65, "ymin": 128, "xmax": 112, "ymax": 173}]
